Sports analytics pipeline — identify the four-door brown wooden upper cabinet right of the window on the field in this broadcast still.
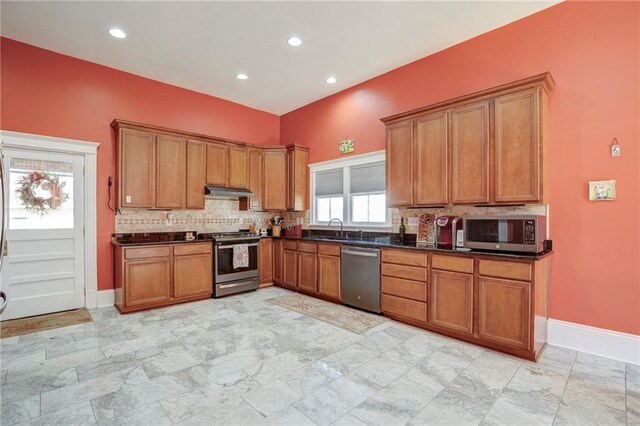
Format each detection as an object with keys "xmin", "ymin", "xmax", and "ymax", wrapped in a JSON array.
[{"xmin": 382, "ymin": 73, "xmax": 555, "ymax": 207}]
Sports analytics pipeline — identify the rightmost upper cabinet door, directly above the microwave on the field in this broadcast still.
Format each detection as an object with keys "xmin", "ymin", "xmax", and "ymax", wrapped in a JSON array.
[{"xmin": 495, "ymin": 89, "xmax": 541, "ymax": 202}]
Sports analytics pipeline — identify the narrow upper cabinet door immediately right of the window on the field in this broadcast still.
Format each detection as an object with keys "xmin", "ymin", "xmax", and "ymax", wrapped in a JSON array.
[{"xmin": 386, "ymin": 121, "xmax": 413, "ymax": 206}]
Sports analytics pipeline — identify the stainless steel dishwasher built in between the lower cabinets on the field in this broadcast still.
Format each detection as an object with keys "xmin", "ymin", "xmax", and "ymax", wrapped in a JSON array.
[{"xmin": 341, "ymin": 246, "xmax": 380, "ymax": 314}]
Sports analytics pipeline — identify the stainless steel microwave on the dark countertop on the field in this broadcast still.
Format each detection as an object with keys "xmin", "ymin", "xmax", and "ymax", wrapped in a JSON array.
[{"xmin": 463, "ymin": 215, "xmax": 547, "ymax": 253}]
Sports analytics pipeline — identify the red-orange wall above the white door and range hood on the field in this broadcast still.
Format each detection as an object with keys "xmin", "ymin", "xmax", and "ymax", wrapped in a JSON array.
[{"xmin": 0, "ymin": 38, "xmax": 280, "ymax": 290}]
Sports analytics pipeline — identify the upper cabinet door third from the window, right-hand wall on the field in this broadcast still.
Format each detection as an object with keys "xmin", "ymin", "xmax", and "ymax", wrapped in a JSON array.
[{"xmin": 451, "ymin": 102, "xmax": 489, "ymax": 204}]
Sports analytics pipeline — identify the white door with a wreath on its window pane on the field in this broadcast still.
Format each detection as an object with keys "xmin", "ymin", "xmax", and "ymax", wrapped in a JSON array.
[{"xmin": 0, "ymin": 148, "xmax": 85, "ymax": 320}]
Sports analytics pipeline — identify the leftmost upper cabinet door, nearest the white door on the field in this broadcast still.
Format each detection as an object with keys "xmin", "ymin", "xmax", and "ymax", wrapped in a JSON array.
[{"xmin": 118, "ymin": 129, "xmax": 156, "ymax": 208}]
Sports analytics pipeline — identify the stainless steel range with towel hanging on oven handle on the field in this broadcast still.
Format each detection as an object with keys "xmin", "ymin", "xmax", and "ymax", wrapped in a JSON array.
[{"xmin": 198, "ymin": 232, "xmax": 260, "ymax": 297}]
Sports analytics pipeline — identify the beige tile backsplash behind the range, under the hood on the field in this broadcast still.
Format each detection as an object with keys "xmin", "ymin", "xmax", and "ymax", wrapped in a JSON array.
[{"xmin": 115, "ymin": 198, "xmax": 308, "ymax": 233}]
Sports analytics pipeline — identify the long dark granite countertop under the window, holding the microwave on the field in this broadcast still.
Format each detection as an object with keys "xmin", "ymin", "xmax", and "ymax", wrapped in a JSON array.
[{"xmin": 274, "ymin": 235, "xmax": 553, "ymax": 260}]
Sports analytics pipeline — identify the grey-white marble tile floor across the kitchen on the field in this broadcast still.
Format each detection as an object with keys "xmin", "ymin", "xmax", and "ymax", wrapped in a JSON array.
[{"xmin": 0, "ymin": 288, "xmax": 640, "ymax": 426}]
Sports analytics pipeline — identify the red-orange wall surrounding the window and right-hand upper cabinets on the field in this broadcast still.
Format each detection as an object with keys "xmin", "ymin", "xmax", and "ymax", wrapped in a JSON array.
[{"xmin": 280, "ymin": 2, "xmax": 640, "ymax": 334}]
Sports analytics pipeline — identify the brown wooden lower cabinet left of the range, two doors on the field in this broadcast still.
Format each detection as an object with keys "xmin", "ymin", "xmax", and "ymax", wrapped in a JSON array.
[{"xmin": 115, "ymin": 243, "xmax": 213, "ymax": 313}]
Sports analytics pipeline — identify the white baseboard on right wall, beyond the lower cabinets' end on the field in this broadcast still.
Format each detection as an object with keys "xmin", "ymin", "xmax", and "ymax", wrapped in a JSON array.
[{"xmin": 547, "ymin": 319, "xmax": 640, "ymax": 365}]
